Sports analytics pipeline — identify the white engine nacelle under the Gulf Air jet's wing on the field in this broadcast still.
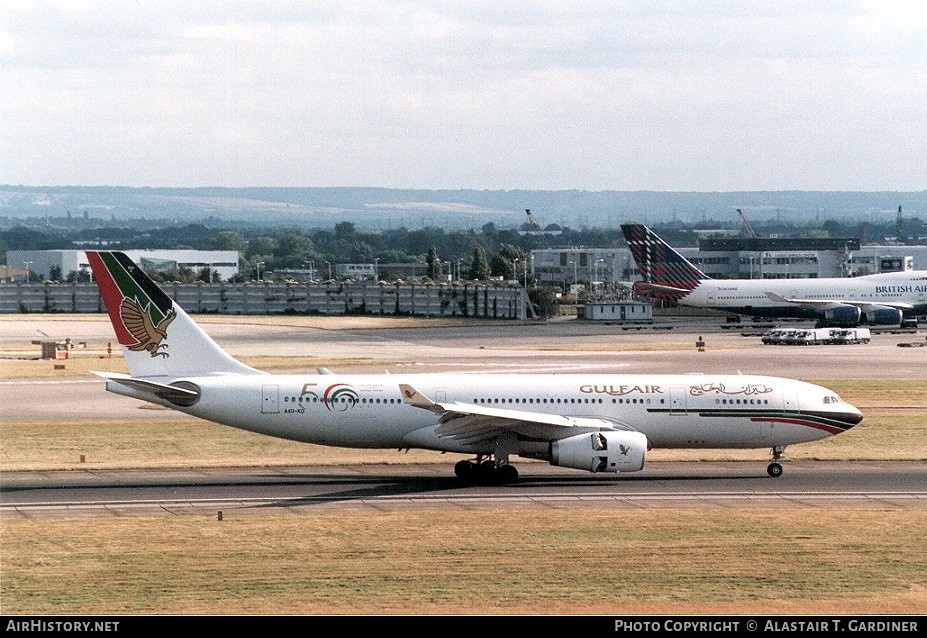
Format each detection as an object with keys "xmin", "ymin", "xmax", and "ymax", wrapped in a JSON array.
[{"xmin": 550, "ymin": 431, "xmax": 648, "ymax": 473}]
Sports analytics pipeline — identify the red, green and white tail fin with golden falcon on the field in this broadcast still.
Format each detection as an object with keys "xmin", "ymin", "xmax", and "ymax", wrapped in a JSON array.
[{"xmin": 87, "ymin": 251, "xmax": 263, "ymax": 378}]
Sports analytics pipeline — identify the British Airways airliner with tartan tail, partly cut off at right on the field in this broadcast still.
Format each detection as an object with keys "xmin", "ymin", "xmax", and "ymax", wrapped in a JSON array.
[{"xmin": 621, "ymin": 224, "xmax": 927, "ymax": 328}]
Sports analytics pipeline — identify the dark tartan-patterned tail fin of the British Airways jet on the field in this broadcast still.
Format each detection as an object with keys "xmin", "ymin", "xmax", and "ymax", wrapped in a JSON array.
[{"xmin": 621, "ymin": 224, "xmax": 711, "ymax": 301}]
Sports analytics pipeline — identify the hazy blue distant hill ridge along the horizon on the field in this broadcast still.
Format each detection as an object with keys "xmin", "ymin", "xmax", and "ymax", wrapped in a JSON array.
[{"xmin": 0, "ymin": 185, "xmax": 927, "ymax": 230}]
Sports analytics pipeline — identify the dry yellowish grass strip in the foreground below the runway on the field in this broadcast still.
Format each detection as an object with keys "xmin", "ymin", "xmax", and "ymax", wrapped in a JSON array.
[{"xmin": 2, "ymin": 507, "xmax": 927, "ymax": 615}]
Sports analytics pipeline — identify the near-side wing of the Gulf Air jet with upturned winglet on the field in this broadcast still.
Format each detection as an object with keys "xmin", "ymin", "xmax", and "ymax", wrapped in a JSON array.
[{"xmin": 399, "ymin": 383, "xmax": 634, "ymax": 442}]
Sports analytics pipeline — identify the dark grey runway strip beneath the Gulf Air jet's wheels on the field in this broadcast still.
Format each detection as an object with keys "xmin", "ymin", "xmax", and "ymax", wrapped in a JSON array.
[{"xmin": 0, "ymin": 461, "xmax": 927, "ymax": 519}]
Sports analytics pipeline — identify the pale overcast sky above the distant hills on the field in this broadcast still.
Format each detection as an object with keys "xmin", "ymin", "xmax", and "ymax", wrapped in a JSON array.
[{"xmin": 0, "ymin": 0, "xmax": 927, "ymax": 191}]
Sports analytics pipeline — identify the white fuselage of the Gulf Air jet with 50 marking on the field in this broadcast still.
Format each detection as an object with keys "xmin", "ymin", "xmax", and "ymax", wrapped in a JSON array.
[{"xmin": 110, "ymin": 374, "xmax": 861, "ymax": 456}]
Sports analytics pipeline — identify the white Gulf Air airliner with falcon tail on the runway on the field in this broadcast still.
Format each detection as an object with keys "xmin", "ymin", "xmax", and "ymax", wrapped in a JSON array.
[{"xmin": 87, "ymin": 251, "xmax": 863, "ymax": 483}]
